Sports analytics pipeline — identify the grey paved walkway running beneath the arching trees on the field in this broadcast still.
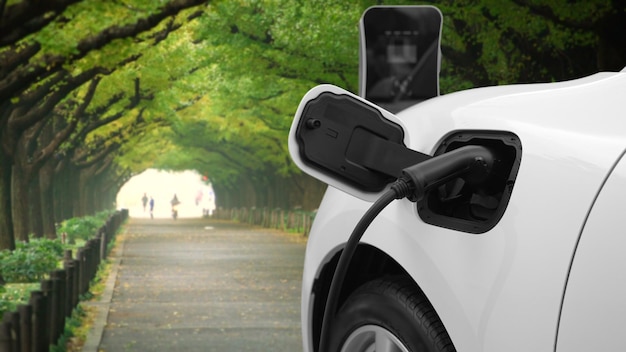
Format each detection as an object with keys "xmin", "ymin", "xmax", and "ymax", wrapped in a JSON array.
[{"xmin": 83, "ymin": 219, "xmax": 305, "ymax": 352}]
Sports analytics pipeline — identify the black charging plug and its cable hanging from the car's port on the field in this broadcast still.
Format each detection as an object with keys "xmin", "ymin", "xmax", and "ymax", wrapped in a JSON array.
[{"xmin": 317, "ymin": 145, "xmax": 495, "ymax": 352}]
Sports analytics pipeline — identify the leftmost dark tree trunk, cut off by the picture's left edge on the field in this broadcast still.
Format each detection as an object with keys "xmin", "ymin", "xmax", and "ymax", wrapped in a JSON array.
[{"xmin": 0, "ymin": 150, "xmax": 15, "ymax": 250}]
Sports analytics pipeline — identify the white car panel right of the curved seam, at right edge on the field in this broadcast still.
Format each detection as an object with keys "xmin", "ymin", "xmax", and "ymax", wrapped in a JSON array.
[{"xmin": 557, "ymin": 151, "xmax": 626, "ymax": 351}]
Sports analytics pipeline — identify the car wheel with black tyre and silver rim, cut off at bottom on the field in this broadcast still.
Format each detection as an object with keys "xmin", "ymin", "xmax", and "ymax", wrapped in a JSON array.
[{"xmin": 330, "ymin": 277, "xmax": 455, "ymax": 352}]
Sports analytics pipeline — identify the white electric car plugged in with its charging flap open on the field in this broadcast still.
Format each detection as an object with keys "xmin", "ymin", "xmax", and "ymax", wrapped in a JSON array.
[{"xmin": 289, "ymin": 7, "xmax": 626, "ymax": 352}]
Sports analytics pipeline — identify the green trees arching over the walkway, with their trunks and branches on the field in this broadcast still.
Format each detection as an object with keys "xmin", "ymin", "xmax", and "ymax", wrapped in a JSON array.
[{"xmin": 0, "ymin": 0, "xmax": 626, "ymax": 248}]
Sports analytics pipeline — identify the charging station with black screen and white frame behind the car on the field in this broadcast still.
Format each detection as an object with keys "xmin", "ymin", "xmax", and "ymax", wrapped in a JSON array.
[{"xmin": 360, "ymin": 6, "xmax": 442, "ymax": 112}]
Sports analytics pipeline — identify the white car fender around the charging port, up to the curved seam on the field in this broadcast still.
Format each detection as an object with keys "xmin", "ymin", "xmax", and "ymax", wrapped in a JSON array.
[{"xmin": 302, "ymin": 73, "xmax": 626, "ymax": 352}]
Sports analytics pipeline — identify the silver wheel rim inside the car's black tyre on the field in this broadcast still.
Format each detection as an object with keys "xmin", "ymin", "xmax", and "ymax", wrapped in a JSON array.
[{"xmin": 341, "ymin": 325, "xmax": 410, "ymax": 352}]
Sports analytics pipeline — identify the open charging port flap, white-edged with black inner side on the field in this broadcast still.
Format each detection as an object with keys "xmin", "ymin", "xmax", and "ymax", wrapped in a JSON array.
[{"xmin": 289, "ymin": 85, "xmax": 429, "ymax": 200}]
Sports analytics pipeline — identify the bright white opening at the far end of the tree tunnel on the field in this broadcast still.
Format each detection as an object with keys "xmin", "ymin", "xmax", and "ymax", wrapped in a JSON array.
[{"xmin": 117, "ymin": 169, "xmax": 215, "ymax": 218}]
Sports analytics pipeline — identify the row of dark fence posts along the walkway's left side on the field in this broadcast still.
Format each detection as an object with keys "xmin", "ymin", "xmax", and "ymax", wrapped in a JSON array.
[{"xmin": 0, "ymin": 209, "xmax": 128, "ymax": 352}]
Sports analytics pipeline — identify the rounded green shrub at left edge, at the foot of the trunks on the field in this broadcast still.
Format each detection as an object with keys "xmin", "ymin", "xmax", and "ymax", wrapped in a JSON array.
[{"xmin": 0, "ymin": 238, "xmax": 63, "ymax": 283}]
